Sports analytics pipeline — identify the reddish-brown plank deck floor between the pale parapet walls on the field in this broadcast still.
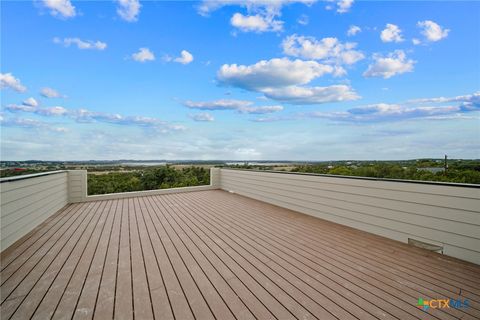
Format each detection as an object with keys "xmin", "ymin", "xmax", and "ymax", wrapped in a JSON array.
[{"xmin": 0, "ymin": 190, "xmax": 480, "ymax": 320}]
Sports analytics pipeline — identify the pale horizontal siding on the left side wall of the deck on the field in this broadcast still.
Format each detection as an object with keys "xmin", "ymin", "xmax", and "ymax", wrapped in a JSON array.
[{"xmin": 0, "ymin": 172, "xmax": 68, "ymax": 251}]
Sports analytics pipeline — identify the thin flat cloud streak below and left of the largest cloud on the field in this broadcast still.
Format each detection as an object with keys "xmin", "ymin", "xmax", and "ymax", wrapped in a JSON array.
[{"xmin": 184, "ymin": 99, "xmax": 283, "ymax": 114}]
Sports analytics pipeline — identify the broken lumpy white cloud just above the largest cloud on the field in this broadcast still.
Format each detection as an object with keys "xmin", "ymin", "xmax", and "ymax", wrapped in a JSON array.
[{"xmin": 282, "ymin": 34, "xmax": 365, "ymax": 64}]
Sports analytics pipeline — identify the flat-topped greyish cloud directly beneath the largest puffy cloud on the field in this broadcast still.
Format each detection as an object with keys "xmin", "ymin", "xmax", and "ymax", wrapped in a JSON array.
[{"xmin": 262, "ymin": 85, "xmax": 360, "ymax": 104}]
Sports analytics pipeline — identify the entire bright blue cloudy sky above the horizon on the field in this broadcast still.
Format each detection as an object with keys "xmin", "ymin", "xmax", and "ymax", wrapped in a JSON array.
[{"xmin": 0, "ymin": 0, "xmax": 480, "ymax": 161}]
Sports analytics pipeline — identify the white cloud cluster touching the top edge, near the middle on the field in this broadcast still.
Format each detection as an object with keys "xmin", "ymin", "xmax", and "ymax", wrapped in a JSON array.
[{"xmin": 198, "ymin": 0, "xmax": 316, "ymax": 33}]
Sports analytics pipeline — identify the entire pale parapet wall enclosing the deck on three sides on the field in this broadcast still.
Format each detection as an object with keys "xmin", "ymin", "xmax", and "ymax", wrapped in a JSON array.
[{"xmin": 0, "ymin": 168, "xmax": 480, "ymax": 264}]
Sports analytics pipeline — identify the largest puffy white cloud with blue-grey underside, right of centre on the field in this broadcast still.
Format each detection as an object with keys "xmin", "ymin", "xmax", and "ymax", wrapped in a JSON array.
[{"xmin": 217, "ymin": 58, "xmax": 334, "ymax": 91}]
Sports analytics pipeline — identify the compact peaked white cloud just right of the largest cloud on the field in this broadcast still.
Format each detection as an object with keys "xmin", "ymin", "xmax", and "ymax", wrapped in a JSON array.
[{"xmin": 363, "ymin": 50, "xmax": 415, "ymax": 79}]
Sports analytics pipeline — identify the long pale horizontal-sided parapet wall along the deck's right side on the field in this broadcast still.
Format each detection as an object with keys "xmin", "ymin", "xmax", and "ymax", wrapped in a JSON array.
[{"xmin": 219, "ymin": 169, "xmax": 480, "ymax": 264}]
